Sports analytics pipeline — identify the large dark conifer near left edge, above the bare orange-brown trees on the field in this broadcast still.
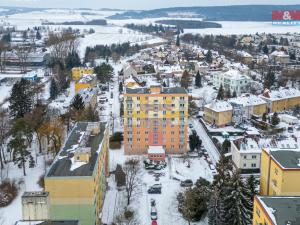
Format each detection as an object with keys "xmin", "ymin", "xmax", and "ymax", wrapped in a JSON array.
[{"xmin": 9, "ymin": 79, "xmax": 33, "ymax": 119}]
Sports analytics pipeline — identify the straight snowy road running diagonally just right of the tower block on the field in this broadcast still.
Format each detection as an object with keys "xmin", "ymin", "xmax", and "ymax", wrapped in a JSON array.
[{"xmin": 190, "ymin": 119, "xmax": 220, "ymax": 165}]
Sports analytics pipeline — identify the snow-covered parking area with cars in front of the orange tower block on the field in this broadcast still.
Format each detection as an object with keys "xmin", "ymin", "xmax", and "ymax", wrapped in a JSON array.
[{"xmin": 136, "ymin": 157, "xmax": 213, "ymax": 225}]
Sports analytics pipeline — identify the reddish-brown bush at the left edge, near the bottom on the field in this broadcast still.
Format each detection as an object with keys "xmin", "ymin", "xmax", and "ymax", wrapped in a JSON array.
[{"xmin": 0, "ymin": 180, "xmax": 18, "ymax": 207}]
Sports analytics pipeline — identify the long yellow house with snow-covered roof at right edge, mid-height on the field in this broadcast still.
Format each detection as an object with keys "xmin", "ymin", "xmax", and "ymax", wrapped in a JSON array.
[{"xmin": 260, "ymin": 87, "xmax": 300, "ymax": 112}]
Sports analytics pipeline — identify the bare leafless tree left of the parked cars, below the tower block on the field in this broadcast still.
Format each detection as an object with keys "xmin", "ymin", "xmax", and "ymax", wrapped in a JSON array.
[{"xmin": 124, "ymin": 159, "xmax": 140, "ymax": 205}]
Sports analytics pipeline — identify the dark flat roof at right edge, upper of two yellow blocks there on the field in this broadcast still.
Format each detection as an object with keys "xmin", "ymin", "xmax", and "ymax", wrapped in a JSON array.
[{"xmin": 270, "ymin": 149, "xmax": 300, "ymax": 169}]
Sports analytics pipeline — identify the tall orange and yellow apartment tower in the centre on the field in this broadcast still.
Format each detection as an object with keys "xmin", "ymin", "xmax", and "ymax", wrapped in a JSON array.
[{"xmin": 124, "ymin": 85, "xmax": 188, "ymax": 155}]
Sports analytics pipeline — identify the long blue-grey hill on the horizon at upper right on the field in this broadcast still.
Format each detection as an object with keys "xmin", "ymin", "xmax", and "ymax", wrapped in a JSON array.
[{"xmin": 107, "ymin": 5, "xmax": 300, "ymax": 21}]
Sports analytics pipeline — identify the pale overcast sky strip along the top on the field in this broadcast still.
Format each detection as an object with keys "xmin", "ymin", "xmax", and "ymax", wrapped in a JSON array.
[{"xmin": 0, "ymin": 0, "xmax": 300, "ymax": 9}]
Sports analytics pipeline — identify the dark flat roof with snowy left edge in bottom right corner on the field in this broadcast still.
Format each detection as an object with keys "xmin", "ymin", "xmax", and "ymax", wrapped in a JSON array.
[{"xmin": 257, "ymin": 196, "xmax": 300, "ymax": 225}]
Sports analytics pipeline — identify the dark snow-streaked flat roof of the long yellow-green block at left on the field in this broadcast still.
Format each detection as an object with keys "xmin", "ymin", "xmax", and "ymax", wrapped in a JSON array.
[{"xmin": 46, "ymin": 122, "xmax": 106, "ymax": 177}]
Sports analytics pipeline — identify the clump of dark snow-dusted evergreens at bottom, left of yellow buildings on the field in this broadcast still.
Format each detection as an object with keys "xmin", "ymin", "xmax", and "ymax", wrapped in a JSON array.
[{"xmin": 177, "ymin": 156, "xmax": 258, "ymax": 225}]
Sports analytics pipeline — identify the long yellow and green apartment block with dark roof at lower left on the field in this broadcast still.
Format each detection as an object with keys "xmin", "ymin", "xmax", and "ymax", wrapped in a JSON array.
[{"xmin": 44, "ymin": 122, "xmax": 109, "ymax": 225}]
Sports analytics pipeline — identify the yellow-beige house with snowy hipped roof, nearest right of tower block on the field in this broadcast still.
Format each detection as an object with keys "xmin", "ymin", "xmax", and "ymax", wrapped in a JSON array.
[{"xmin": 203, "ymin": 100, "xmax": 232, "ymax": 127}]
